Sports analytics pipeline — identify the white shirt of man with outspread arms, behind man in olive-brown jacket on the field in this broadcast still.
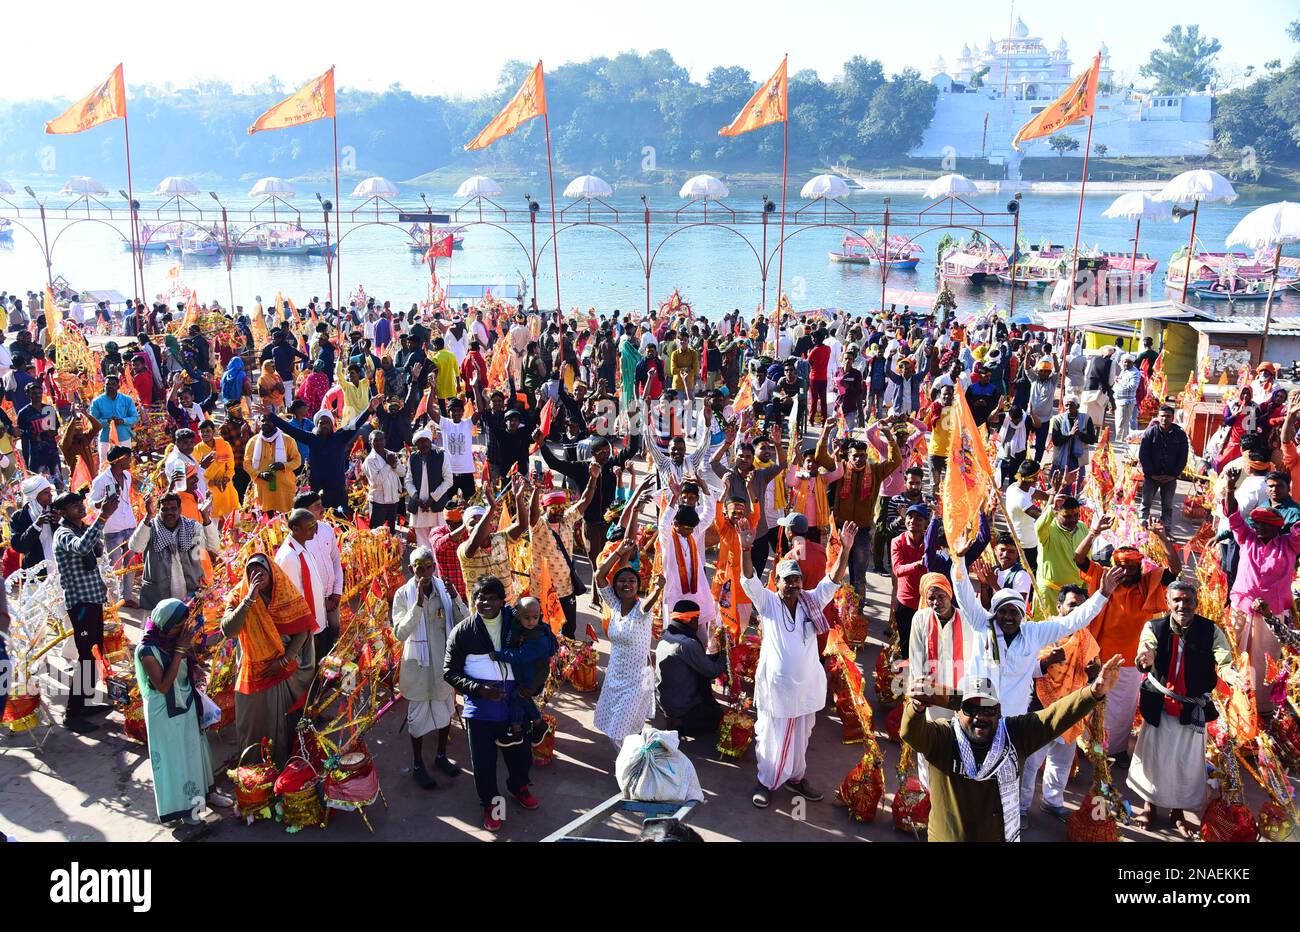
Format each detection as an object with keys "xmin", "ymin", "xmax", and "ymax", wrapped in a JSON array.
[{"xmin": 953, "ymin": 560, "xmax": 1108, "ymax": 716}]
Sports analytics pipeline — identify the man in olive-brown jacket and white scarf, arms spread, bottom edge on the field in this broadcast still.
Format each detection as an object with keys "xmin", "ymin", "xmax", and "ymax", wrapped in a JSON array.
[{"xmin": 898, "ymin": 656, "xmax": 1123, "ymax": 841}]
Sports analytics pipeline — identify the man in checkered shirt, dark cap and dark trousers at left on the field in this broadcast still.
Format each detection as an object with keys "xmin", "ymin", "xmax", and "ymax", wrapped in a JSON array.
[{"xmin": 52, "ymin": 491, "xmax": 118, "ymax": 734}]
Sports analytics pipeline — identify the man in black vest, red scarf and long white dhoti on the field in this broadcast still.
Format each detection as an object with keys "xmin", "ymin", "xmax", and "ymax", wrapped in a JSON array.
[{"xmin": 1128, "ymin": 580, "xmax": 1238, "ymax": 838}]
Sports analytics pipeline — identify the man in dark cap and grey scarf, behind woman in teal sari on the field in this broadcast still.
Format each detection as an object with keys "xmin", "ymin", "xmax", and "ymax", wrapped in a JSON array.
[{"xmin": 128, "ymin": 491, "xmax": 221, "ymax": 610}]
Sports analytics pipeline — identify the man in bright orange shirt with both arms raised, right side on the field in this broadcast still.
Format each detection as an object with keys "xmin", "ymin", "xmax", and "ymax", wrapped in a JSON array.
[{"xmin": 1074, "ymin": 513, "xmax": 1183, "ymax": 755}]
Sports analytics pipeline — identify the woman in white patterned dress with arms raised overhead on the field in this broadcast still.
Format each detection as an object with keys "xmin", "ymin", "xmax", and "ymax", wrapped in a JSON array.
[{"xmin": 595, "ymin": 537, "xmax": 654, "ymax": 747}]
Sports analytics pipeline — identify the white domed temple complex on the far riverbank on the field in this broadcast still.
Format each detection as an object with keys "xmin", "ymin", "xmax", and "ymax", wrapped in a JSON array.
[{"xmin": 910, "ymin": 19, "xmax": 1213, "ymax": 170}]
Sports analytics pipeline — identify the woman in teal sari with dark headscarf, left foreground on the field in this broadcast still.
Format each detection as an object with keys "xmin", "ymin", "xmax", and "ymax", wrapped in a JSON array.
[{"xmin": 135, "ymin": 599, "xmax": 233, "ymax": 824}]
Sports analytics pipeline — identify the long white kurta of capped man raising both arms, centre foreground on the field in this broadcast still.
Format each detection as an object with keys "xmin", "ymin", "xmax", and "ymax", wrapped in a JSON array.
[{"xmin": 741, "ymin": 576, "xmax": 840, "ymax": 719}]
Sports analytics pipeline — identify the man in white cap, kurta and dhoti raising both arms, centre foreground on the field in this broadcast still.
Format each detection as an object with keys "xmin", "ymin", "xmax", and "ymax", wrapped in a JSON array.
[{"xmin": 738, "ymin": 521, "xmax": 858, "ymax": 809}]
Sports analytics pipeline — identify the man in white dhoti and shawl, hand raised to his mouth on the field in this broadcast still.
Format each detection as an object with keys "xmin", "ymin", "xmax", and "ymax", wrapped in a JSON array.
[{"xmin": 393, "ymin": 547, "xmax": 469, "ymax": 789}]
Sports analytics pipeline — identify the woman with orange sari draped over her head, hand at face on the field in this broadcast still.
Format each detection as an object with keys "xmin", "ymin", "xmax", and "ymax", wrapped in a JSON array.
[{"xmin": 221, "ymin": 554, "xmax": 316, "ymax": 767}]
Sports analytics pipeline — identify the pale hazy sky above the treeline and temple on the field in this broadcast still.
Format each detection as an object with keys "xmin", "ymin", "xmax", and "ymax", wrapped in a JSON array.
[{"xmin": 0, "ymin": 0, "xmax": 1300, "ymax": 100}]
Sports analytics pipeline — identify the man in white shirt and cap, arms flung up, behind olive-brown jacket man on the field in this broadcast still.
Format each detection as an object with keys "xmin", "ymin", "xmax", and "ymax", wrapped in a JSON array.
[{"xmin": 953, "ymin": 547, "xmax": 1126, "ymax": 822}]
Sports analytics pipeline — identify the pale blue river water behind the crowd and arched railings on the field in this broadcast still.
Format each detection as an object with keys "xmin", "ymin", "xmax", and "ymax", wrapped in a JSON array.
[{"xmin": 0, "ymin": 179, "xmax": 1300, "ymax": 317}]
